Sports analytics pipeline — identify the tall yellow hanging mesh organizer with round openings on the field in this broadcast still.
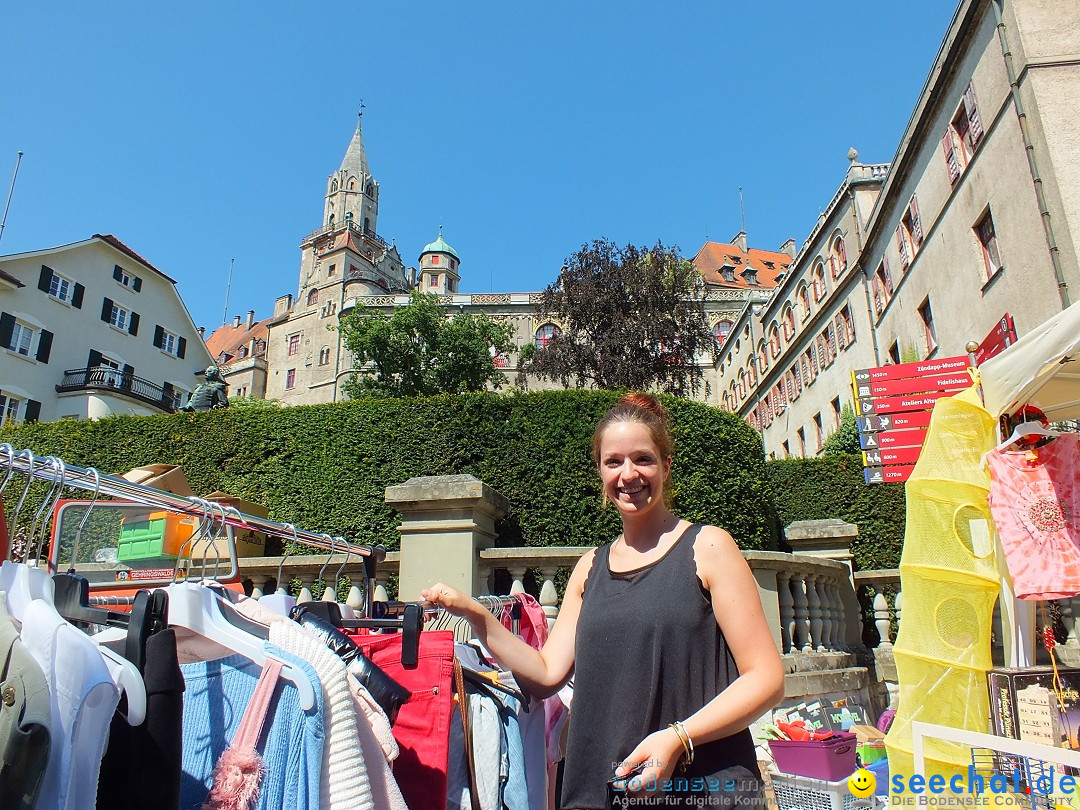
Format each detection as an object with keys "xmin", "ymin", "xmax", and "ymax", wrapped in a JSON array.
[{"xmin": 885, "ymin": 386, "xmax": 999, "ymax": 784}]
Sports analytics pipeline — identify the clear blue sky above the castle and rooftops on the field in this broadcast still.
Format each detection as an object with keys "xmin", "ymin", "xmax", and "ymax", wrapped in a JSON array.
[{"xmin": 0, "ymin": 0, "xmax": 955, "ymax": 328}]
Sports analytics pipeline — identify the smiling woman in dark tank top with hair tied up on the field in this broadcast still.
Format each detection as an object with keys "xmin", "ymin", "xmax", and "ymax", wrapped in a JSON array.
[{"xmin": 423, "ymin": 393, "xmax": 784, "ymax": 810}]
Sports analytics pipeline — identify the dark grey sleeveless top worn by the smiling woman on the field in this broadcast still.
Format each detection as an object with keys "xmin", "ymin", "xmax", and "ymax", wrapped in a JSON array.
[{"xmin": 561, "ymin": 525, "xmax": 760, "ymax": 808}]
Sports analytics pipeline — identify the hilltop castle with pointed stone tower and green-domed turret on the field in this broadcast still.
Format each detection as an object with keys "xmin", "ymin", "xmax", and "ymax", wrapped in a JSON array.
[{"xmin": 254, "ymin": 114, "xmax": 777, "ymax": 405}]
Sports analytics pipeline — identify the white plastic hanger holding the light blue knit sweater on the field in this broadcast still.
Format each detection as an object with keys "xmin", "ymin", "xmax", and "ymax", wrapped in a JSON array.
[{"xmin": 165, "ymin": 499, "xmax": 315, "ymax": 711}]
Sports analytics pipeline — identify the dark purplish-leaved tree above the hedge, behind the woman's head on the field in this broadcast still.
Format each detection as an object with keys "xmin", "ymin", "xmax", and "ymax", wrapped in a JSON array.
[{"xmin": 521, "ymin": 240, "xmax": 715, "ymax": 396}]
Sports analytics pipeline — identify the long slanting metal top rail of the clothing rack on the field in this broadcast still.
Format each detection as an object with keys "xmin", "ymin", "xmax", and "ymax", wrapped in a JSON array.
[{"xmin": 0, "ymin": 444, "xmax": 387, "ymax": 616}]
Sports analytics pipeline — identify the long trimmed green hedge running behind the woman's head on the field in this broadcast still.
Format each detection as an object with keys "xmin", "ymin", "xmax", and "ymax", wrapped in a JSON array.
[{"xmin": 0, "ymin": 391, "xmax": 778, "ymax": 549}]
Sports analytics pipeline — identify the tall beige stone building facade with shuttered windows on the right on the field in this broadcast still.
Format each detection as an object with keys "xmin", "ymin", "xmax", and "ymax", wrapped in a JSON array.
[{"xmin": 716, "ymin": 0, "xmax": 1080, "ymax": 457}]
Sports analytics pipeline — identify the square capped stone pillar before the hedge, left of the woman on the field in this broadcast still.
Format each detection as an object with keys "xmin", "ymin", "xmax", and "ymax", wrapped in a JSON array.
[{"xmin": 386, "ymin": 475, "xmax": 510, "ymax": 602}]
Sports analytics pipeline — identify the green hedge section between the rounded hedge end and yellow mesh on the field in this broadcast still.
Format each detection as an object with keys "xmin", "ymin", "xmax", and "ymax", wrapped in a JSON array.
[{"xmin": 766, "ymin": 456, "xmax": 905, "ymax": 570}]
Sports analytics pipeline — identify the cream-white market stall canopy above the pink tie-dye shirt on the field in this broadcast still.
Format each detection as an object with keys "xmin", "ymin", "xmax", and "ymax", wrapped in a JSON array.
[{"xmin": 978, "ymin": 302, "xmax": 1080, "ymax": 422}]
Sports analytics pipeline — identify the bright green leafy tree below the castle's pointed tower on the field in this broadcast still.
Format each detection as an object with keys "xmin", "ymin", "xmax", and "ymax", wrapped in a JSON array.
[{"xmin": 340, "ymin": 292, "xmax": 514, "ymax": 396}]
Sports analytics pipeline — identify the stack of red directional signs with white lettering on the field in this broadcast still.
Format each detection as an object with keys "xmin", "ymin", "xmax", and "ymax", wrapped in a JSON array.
[{"xmin": 851, "ymin": 354, "xmax": 972, "ymax": 484}]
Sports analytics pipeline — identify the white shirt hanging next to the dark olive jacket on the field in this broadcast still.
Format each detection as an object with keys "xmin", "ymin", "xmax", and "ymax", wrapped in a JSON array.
[{"xmin": 22, "ymin": 599, "xmax": 120, "ymax": 810}]
